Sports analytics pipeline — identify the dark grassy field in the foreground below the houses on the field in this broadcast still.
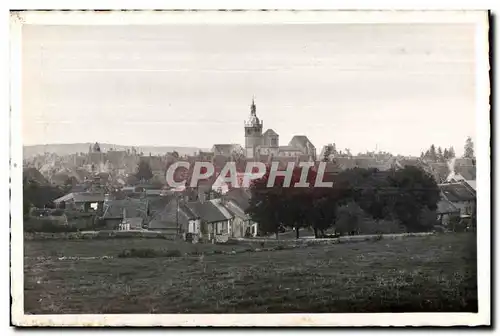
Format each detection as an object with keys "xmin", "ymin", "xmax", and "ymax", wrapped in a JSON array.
[{"xmin": 24, "ymin": 233, "xmax": 477, "ymax": 314}]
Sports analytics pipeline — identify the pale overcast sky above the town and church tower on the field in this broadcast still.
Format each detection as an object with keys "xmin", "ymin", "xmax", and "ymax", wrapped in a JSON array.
[{"xmin": 22, "ymin": 24, "xmax": 476, "ymax": 155}]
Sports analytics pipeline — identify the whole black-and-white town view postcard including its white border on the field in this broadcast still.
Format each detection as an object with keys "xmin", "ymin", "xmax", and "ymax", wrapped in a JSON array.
[{"xmin": 10, "ymin": 10, "xmax": 491, "ymax": 326}]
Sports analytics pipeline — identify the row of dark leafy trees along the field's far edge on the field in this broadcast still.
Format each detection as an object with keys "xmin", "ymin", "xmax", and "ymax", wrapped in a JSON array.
[{"xmin": 248, "ymin": 166, "xmax": 440, "ymax": 238}]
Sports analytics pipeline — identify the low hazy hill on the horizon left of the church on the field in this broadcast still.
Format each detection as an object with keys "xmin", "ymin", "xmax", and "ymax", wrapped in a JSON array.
[{"xmin": 23, "ymin": 143, "xmax": 207, "ymax": 158}]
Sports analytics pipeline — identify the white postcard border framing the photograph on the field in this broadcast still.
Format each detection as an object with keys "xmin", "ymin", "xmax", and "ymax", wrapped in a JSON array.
[{"xmin": 10, "ymin": 11, "xmax": 491, "ymax": 326}]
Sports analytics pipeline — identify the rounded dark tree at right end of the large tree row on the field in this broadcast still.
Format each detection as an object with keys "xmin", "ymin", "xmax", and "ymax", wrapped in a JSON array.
[{"xmin": 388, "ymin": 166, "xmax": 440, "ymax": 231}]
